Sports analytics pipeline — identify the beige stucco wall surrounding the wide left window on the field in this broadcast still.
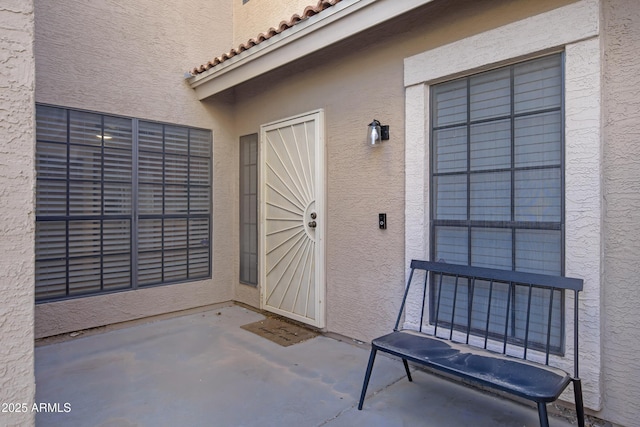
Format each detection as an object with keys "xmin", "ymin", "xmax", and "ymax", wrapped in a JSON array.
[{"xmin": 35, "ymin": 0, "xmax": 237, "ymax": 337}]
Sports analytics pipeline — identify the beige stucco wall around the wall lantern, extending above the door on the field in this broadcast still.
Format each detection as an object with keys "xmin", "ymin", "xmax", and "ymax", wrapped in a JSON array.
[{"xmin": 229, "ymin": 0, "xmax": 567, "ymax": 341}]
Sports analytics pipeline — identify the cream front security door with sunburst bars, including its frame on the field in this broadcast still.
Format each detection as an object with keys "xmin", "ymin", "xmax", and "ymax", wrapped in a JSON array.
[{"xmin": 260, "ymin": 110, "xmax": 326, "ymax": 328}]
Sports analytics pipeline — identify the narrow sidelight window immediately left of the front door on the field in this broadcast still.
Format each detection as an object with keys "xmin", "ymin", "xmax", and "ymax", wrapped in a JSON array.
[{"xmin": 240, "ymin": 134, "xmax": 258, "ymax": 285}]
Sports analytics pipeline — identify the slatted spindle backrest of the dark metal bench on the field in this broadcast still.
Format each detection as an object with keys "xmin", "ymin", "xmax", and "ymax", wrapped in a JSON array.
[{"xmin": 395, "ymin": 260, "xmax": 583, "ymax": 378}]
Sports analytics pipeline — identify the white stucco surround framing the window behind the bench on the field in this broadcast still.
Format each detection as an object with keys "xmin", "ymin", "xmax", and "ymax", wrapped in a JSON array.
[{"xmin": 404, "ymin": 0, "xmax": 602, "ymax": 410}]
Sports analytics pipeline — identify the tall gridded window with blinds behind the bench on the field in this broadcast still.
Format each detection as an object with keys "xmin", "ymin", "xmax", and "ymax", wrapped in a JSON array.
[{"xmin": 430, "ymin": 54, "xmax": 564, "ymax": 352}]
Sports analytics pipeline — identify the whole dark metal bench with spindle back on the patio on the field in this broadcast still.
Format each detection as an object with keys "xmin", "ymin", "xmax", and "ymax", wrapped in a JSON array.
[{"xmin": 358, "ymin": 260, "xmax": 584, "ymax": 427}]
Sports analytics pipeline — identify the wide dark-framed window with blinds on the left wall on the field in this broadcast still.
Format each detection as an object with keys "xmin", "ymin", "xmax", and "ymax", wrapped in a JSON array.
[{"xmin": 36, "ymin": 105, "xmax": 211, "ymax": 301}]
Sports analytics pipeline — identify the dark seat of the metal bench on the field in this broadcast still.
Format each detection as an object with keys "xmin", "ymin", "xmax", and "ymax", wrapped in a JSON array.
[{"xmin": 371, "ymin": 331, "xmax": 571, "ymax": 402}]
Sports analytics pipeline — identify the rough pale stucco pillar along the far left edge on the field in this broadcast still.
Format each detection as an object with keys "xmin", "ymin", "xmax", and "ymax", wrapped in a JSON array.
[{"xmin": 0, "ymin": 0, "xmax": 35, "ymax": 426}]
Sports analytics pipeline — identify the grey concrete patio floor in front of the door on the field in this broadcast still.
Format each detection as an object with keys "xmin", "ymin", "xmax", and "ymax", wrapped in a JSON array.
[{"xmin": 35, "ymin": 306, "xmax": 571, "ymax": 427}]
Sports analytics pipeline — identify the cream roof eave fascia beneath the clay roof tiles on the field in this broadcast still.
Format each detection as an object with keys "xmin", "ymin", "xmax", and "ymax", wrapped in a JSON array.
[{"xmin": 189, "ymin": 0, "xmax": 435, "ymax": 100}]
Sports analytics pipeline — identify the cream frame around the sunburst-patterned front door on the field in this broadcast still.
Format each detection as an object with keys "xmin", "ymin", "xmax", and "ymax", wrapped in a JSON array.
[{"xmin": 258, "ymin": 109, "xmax": 327, "ymax": 329}]
